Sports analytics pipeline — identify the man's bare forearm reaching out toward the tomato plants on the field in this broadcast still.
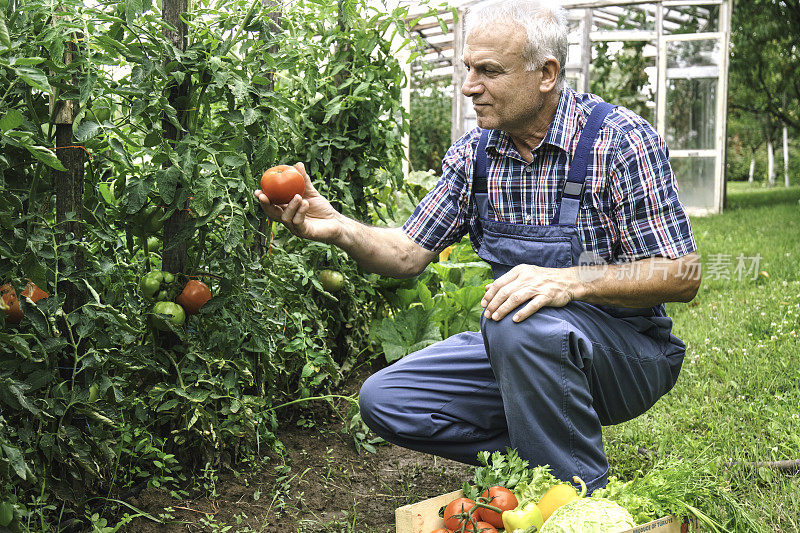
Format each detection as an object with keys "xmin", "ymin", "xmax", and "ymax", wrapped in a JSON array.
[{"xmin": 331, "ymin": 216, "xmax": 435, "ymax": 278}]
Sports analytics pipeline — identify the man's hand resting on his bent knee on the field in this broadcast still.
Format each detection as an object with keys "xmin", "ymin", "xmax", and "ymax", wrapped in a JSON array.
[{"xmin": 481, "ymin": 265, "xmax": 579, "ymax": 322}]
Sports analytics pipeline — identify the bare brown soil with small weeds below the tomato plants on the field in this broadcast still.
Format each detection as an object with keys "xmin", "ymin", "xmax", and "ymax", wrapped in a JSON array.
[{"xmin": 124, "ymin": 366, "xmax": 473, "ymax": 533}]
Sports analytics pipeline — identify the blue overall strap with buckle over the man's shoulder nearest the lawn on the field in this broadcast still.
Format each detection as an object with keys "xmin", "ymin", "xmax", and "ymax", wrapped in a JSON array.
[{"xmin": 554, "ymin": 102, "xmax": 614, "ymax": 226}]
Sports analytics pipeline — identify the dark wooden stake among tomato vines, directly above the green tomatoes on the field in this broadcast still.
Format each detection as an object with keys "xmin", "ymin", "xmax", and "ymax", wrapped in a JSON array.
[{"xmin": 161, "ymin": 0, "xmax": 191, "ymax": 273}]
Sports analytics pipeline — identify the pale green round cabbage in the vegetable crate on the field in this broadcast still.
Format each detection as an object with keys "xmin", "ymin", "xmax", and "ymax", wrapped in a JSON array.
[{"xmin": 540, "ymin": 498, "xmax": 636, "ymax": 533}]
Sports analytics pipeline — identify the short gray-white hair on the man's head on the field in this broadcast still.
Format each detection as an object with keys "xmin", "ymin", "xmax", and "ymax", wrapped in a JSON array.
[{"xmin": 466, "ymin": 0, "xmax": 569, "ymax": 87}]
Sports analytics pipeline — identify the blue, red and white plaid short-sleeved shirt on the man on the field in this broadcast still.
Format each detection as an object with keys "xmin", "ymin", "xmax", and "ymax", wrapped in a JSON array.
[{"xmin": 403, "ymin": 87, "xmax": 697, "ymax": 263}]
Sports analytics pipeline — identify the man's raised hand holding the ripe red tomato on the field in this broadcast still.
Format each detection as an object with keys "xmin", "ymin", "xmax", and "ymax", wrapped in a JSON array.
[{"xmin": 253, "ymin": 163, "xmax": 343, "ymax": 242}]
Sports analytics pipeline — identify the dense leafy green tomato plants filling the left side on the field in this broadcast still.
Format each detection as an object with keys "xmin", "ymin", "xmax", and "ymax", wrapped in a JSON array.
[{"xmin": 0, "ymin": 0, "xmax": 416, "ymax": 529}]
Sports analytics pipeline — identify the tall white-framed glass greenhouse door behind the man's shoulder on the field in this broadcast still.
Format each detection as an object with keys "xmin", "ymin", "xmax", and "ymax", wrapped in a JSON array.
[{"xmin": 656, "ymin": 0, "xmax": 730, "ymax": 215}]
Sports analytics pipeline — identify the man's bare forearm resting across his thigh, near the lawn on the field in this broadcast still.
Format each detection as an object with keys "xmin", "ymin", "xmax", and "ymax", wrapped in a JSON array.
[{"xmin": 571, "ymin": 254, "xmax": 701, "ymax": 307}]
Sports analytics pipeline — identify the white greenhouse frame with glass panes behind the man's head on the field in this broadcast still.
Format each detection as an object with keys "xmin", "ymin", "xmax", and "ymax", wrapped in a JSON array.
[{"xmin": 401, "ymin": 0, "xmax": 732, "ymax": 215}]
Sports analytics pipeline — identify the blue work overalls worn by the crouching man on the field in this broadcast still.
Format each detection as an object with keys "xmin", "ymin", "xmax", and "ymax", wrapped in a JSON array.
[{"xmin": 359, "ymin": 103, "xmax": 685, "ymax": 491}]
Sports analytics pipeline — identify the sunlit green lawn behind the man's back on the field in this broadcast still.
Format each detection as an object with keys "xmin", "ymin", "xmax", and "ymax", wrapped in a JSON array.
[{"xmin": 606, "ymin": 183, "xmax": 800, "ymax": 531}]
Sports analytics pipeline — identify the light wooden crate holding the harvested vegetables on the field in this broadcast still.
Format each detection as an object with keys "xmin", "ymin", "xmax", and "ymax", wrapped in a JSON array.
[{"xmin": 394, "ymin": 490, "xmax": 700, "ymax": 533}]
